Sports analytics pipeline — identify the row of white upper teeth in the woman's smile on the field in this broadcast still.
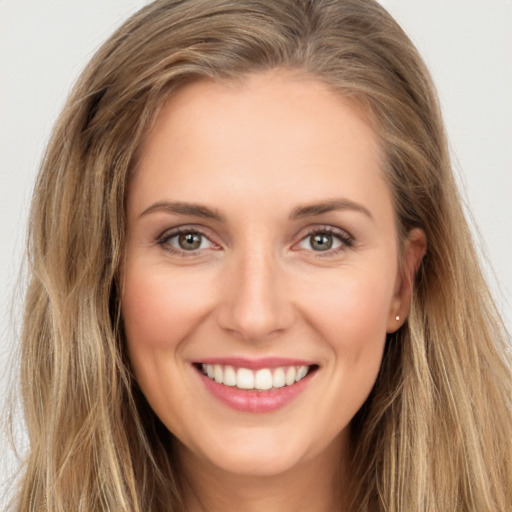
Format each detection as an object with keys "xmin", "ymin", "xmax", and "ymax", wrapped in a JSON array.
[{"xmin": 201, "ymin": 364, "xmax": 309, "ymax": 391}]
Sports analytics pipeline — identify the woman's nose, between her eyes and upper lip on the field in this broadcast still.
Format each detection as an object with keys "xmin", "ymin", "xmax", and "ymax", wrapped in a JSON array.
[{"xmin": 217, "ymin": 247, "xmax": 295, "ymax": 342}]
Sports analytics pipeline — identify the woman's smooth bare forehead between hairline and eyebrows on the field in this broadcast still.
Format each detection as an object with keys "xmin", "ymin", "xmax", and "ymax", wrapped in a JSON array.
[{"xmin": 129, "ymin": 71, "xmax": 388, "ymax": 223}]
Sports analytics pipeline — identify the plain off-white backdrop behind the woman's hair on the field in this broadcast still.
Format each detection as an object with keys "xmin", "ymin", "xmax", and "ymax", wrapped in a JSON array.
[{"xmin": 0, "ymin": 0, "xmax": 512, "ymax": 506}]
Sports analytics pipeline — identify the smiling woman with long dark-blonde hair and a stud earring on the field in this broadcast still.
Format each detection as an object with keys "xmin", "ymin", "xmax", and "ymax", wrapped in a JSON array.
[{"xmin": 12, "ymin": 0, "xmax": 512, "ymax": 512}]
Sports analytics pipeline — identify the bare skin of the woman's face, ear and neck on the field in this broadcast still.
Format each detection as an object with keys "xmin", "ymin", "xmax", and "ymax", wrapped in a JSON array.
[{"xmin": 122, "ymin": 71, "xmax": 425, "ymax": 512}]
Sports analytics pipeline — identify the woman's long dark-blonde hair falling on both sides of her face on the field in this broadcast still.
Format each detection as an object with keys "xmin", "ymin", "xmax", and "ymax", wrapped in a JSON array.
[{"xmin": 17, "ymin": 0, "xmax": 512, "ymax": 512}]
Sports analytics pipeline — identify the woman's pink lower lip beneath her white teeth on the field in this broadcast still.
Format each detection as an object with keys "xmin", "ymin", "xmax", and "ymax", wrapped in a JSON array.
[{"xmin": 198, "ymin": 372, "xmax": 315, "ymax": 413}]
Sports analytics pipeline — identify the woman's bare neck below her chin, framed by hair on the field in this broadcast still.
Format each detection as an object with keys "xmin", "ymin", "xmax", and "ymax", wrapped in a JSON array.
[{"xmin": 180, "ymin": 434, "xmax": 348, "ymax": 512}]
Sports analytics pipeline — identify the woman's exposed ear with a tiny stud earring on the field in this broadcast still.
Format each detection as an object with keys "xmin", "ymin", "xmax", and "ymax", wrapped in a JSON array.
[{"xmin": 386, "ymin": 228, "xmax": 427, "ymax": 333}]
